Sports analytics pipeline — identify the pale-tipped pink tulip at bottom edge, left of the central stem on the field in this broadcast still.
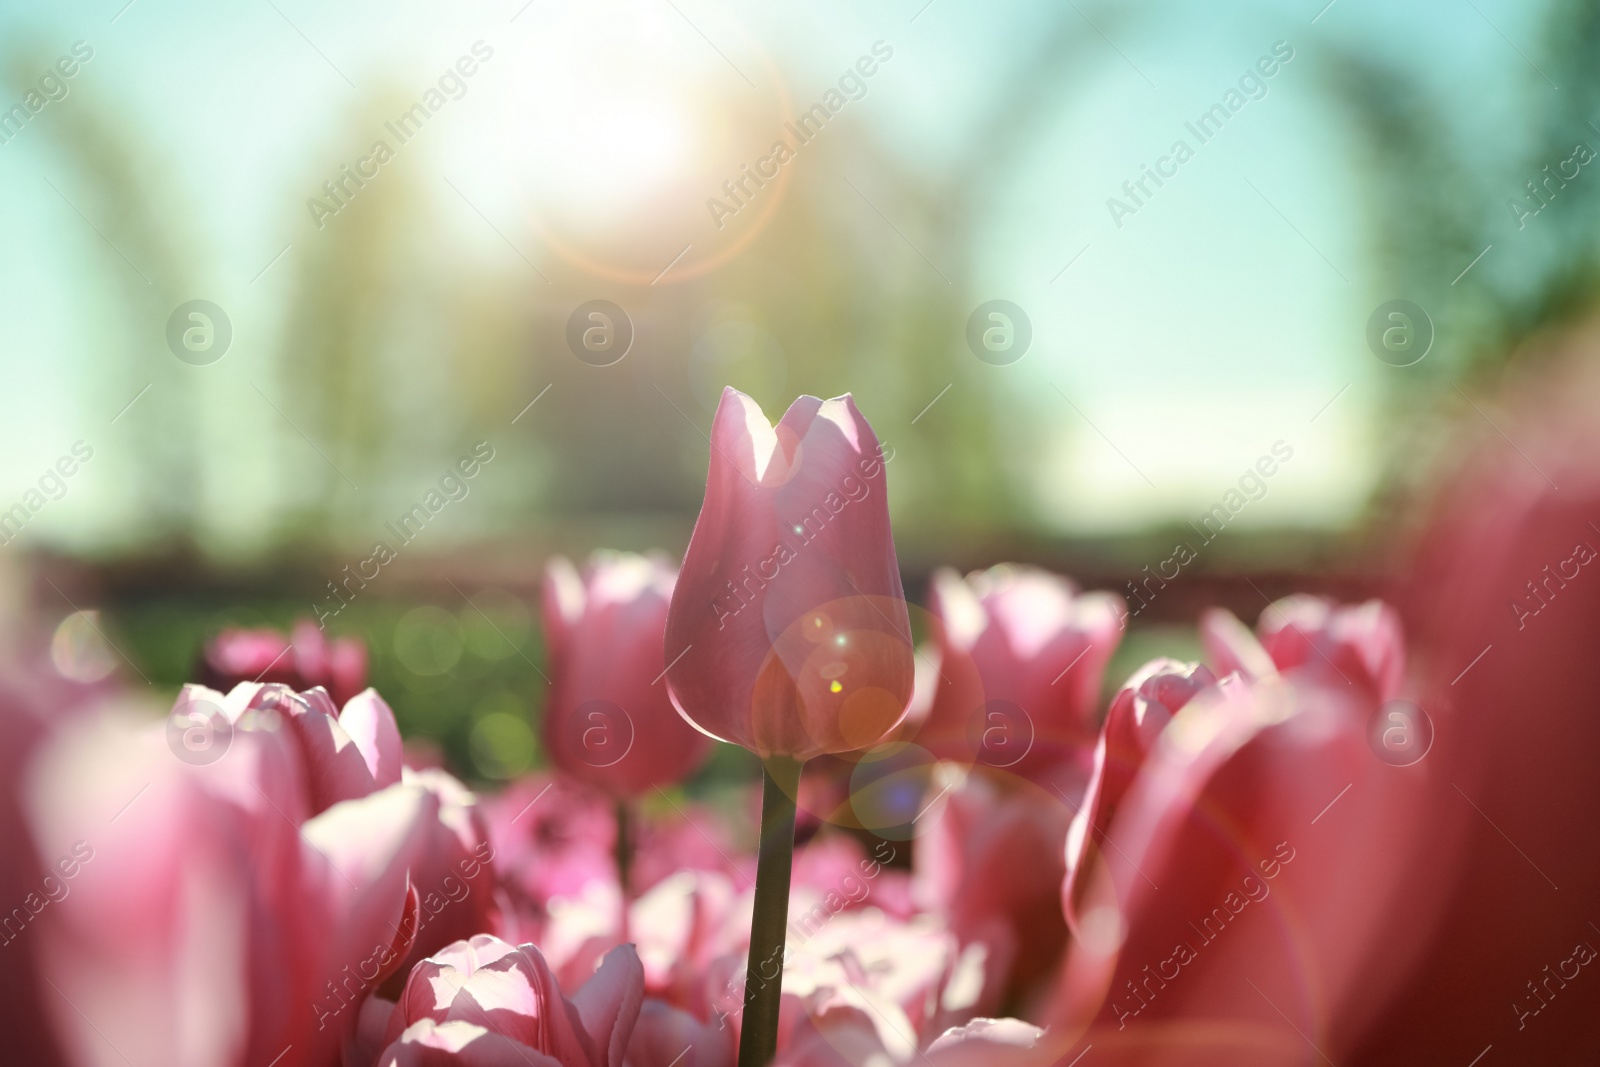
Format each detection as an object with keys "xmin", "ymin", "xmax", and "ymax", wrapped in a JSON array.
[{"xmin": 376, "ymin": 934, "xmax": 643, "ymax": 1067}]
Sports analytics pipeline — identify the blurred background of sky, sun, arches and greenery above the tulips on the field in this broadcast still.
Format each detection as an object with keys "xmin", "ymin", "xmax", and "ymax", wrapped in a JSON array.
[{"xmin": 0, "ymin": 0, "xmax": 1600, "ymax": 781}]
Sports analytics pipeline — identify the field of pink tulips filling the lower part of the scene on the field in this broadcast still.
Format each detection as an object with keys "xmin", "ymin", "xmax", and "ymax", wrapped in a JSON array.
[{"xmin": 3, "ymin": 374, "xmax": 1600, "ymax": 1067}]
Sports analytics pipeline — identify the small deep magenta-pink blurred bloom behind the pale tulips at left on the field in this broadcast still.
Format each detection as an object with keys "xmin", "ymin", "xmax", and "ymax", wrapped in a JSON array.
[{"xmin": 195, "ymin": 619, "xmax": 366, "ymax": 705}]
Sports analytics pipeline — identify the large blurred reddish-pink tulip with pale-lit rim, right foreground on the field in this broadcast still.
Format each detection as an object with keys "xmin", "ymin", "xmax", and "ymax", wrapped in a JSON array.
[{"xmin": 1051, "ymin": 609, "xmax": 1429, "ymax": 1064}]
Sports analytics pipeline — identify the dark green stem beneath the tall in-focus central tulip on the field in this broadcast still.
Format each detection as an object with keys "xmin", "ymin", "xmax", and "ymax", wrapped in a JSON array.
[{"xmin": 739, "ymin": 755, "xmax": 802, "ymax": 1067}]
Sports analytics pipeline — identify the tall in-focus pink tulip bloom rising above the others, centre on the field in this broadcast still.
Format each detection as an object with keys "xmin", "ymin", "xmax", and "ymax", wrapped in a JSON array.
[{"xmin": 666, "ymin": 389, "xmax": 912, "ymax": 760}]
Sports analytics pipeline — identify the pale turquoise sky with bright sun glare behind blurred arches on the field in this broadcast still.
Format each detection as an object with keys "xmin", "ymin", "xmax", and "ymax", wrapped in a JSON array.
[{"xmin": 0, "ymin": 0, "xmax": 1541, "ymax": 545}]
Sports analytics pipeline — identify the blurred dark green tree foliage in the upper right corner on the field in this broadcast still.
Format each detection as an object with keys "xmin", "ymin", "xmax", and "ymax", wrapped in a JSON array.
[{"xmin": 1323, "ymin": 0, "xmax": 1600, "ymax": 515}]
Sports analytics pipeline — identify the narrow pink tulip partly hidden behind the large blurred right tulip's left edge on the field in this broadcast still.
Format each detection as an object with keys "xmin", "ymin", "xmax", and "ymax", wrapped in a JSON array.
[{"xmin": 1061, "ymin": 659, "xmax": 1216, "ymax": 931}]
